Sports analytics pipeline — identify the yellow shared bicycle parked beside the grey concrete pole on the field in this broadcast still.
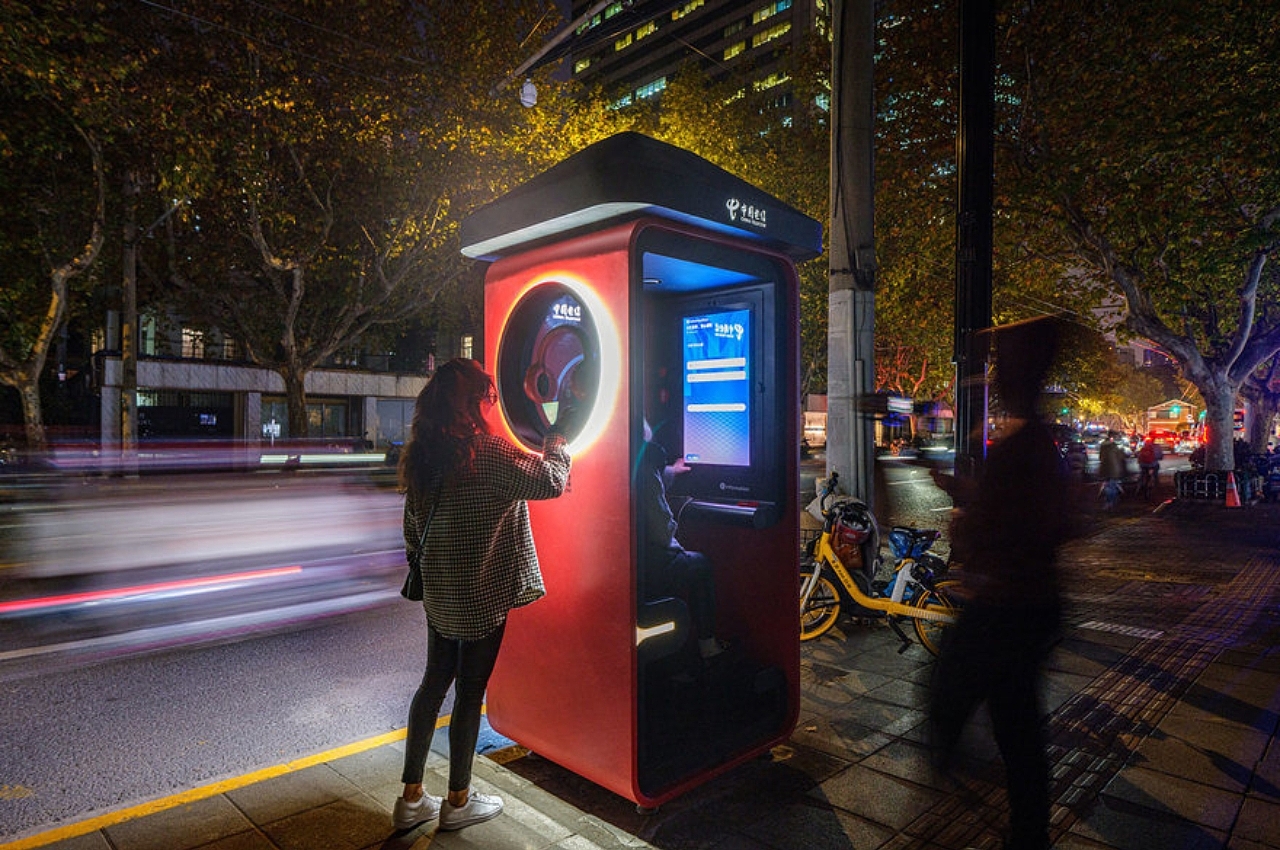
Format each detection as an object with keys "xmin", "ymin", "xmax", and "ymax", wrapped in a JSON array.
[{"xmin": 800, "ymin": 472, "xmax": 960, "ymax": 655}]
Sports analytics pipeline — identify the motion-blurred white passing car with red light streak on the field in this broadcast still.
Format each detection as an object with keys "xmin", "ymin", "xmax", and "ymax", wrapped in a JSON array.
[{"xmin": 0, "ymin": 472, "xmax": 404, "ymax": 668}]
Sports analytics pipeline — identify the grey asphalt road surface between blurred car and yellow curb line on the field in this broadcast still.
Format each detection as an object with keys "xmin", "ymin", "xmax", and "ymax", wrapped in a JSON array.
[{"xmin": 0, "ymin": 600, "xmax": 426, "ymax": 838}]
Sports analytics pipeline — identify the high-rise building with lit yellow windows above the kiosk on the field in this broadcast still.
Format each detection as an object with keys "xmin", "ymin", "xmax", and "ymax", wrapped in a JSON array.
[{"xmin": 568, "ymin": 0, "xmax": 831, "ymax": 108}]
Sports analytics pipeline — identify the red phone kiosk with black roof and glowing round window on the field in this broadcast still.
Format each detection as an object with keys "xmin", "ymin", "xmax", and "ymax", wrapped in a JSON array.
[{"xmin": 462, "ymin": 133, "xmax": 822, "ymax": 806}]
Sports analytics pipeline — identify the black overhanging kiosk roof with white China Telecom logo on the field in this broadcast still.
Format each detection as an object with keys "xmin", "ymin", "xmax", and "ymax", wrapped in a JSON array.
[{"xmin": 461, "ymin": 133, "xmax": 822, "ymax": 260}]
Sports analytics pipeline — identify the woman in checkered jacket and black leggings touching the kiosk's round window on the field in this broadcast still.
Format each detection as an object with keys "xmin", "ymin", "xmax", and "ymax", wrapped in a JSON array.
[{"xmin": 393, "ymin": 358, "xmax": 570, "ymax": 830}]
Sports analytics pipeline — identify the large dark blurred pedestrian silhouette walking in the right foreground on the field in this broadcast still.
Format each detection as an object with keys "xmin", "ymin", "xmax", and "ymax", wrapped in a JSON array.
[{"xmin": 929, "ymin": 319, "xmax": 1073, "ymax": 850}]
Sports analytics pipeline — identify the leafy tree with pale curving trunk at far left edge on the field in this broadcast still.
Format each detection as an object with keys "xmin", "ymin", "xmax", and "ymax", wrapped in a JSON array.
[{"xmin": 0, "ymin": 4, "xmax": 110, "ymax": 452}]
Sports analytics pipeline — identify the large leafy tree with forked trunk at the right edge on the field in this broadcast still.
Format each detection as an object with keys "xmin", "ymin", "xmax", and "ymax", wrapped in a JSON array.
[{"xmin": 1000, "ymin": 0, "xmax": 1280, "ymax": 470}]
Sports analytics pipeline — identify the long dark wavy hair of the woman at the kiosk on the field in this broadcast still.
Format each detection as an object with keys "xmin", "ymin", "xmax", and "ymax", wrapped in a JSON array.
[{"xmin": 399, "ymin": 357, "xmax": 493, "ymax": 498}]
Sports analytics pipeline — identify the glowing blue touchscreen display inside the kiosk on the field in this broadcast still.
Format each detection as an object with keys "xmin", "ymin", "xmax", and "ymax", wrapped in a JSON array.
[{"xmin": 684, "ymin": 309, "xmax": 751, "ymax": 466}]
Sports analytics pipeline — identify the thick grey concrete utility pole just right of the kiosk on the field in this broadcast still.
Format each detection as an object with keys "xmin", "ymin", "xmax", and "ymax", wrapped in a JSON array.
[{"xmin": 827, "ymin": 0, "xmax": 876, "ymax": 508}]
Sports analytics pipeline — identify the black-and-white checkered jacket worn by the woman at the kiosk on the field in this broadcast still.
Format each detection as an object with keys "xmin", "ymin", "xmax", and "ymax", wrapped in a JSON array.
[{"xmin": 404, "ymin": 434, "xmax": 570, "ymax": 640}]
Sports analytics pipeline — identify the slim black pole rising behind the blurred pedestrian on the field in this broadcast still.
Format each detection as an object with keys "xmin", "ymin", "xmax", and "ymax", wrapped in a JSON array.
[{"xmin": 954, "ymin": 0, "xmax": 996, "ymax": 476}]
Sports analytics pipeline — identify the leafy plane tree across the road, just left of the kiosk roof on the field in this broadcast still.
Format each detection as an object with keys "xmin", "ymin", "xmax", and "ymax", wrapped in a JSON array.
[{"xmin": 153, "ymin": 0, "xmax": 560, "ymax": 437}]
